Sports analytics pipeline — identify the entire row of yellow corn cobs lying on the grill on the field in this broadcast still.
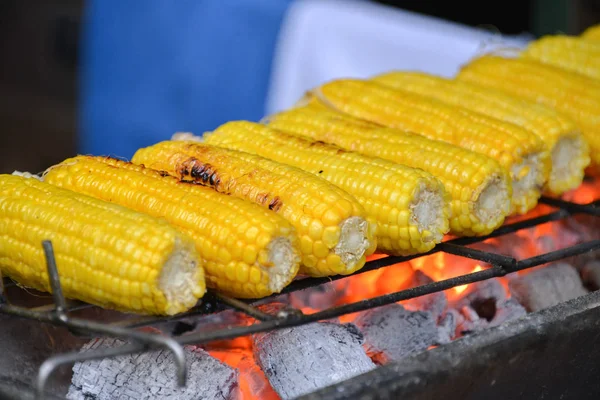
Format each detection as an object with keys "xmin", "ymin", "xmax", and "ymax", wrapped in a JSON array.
[{"xmin": 0, "ymin": 29, "xmax": 600, "ymax": 315}]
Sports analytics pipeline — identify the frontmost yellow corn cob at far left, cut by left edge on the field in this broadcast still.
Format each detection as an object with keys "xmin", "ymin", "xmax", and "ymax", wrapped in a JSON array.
[{"xmin": 0, "ymin": 175, "xmax": 205, "ymax": 315}]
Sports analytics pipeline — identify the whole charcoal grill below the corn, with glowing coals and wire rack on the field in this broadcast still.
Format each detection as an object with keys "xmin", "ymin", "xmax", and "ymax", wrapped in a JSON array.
[{"xmin": 0, "ymin": 180, "xmax": 600, "ymax": 400}]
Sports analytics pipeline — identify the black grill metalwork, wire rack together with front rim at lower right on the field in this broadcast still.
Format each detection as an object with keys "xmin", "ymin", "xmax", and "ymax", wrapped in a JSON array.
[{"xmin": 0, "ymin": 193, "xmax": 600, "ymax": 399}]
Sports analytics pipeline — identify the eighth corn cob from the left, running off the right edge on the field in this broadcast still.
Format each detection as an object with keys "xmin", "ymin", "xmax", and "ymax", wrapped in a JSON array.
[{"xmin": 457, "ymin": 56, "xmax": 600, "ymax": 165}]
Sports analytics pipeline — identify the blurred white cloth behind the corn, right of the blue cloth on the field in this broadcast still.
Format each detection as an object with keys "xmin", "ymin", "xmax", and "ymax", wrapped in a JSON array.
[{"xmin": 266, "ymin": 0, "xmax": 530, "ymax": 114}]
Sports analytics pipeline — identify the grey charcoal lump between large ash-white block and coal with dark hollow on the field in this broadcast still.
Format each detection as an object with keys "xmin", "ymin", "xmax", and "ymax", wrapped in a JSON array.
[{"xmin": 355, "ymin": 304, "xmax": 450, "ymax": 364}]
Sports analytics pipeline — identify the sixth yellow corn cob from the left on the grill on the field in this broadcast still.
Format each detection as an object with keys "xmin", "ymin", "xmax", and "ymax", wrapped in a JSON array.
[{"xmin": 314, "ymin": 79, "xmax": 550, "ymax": 213}]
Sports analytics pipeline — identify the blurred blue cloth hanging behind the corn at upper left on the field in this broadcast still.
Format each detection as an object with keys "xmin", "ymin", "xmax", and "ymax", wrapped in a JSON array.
[{"xmin": 78, "ymin": 0, "xmax": 293, "ymax": 158}]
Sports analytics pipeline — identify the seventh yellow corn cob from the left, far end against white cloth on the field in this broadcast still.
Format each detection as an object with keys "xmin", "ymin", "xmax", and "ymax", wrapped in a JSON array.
[{"xmin": 374, "ymin": 71, "xmax": 590, "ymax": 194}]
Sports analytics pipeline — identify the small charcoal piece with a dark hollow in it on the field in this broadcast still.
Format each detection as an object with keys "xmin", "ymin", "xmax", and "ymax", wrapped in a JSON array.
[{"xmin": 456, "ymin": 299, "xmax": 527, "ymax": 335}]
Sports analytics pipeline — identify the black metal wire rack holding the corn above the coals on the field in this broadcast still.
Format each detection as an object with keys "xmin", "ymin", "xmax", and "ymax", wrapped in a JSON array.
[{"xmin": 0, "ymin": 197, "xmax": 600, "ymax": 398}]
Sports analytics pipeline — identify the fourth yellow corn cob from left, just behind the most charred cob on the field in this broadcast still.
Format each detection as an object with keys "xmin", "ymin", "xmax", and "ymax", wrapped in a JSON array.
[{"xmin": 204, "ymin": 121, "xmax": 449, "ymax": 257}]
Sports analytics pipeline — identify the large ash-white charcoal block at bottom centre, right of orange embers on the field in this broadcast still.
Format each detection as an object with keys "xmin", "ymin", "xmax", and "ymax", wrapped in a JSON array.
[{"xmin": 253, "ymin": 322, "xmax": 375, "ymax": 399}]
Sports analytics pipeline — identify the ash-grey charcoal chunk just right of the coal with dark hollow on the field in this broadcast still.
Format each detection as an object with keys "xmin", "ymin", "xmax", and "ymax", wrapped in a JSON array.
[{"xmin": 508, "ymin": 263, "xmax": 587, "ymax": 311}]
